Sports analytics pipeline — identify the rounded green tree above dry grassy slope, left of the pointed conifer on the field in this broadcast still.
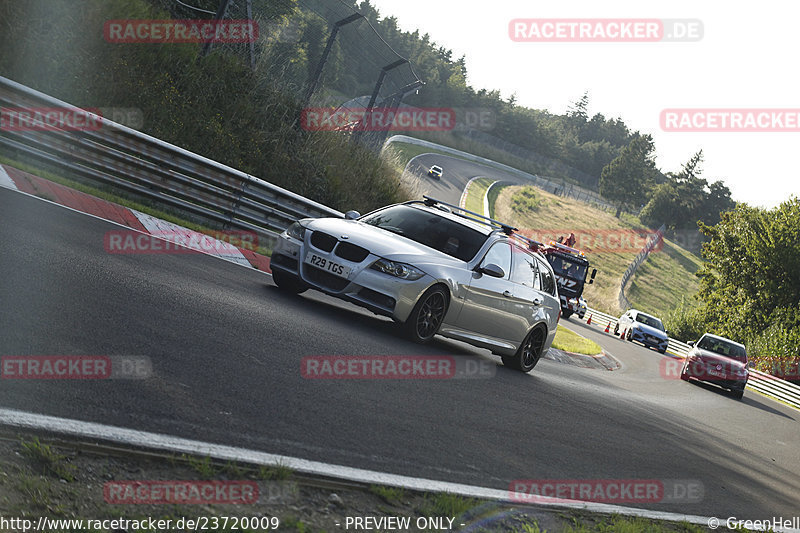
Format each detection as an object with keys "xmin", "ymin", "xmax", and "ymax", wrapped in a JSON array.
[{"xmin": 600, "ymin": 135, "xmax": 658, "ymax": 217}]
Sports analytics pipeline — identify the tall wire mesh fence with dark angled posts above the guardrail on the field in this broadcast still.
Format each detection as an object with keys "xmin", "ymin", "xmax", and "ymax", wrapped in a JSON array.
[{"xmin": 150, "ymin": 0, "xmax": 424, "ymax": 150}]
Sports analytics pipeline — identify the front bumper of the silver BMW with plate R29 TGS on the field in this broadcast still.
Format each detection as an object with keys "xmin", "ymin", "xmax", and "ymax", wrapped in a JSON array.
[{"xmin": 270, "ymin": 231, "xmax": 435, "ymax": 322}]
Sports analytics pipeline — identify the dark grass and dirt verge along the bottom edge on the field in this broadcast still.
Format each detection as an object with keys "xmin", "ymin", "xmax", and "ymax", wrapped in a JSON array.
[{"xmin": 0, "ymin": 429, "xmax": 709, "ymax": 533}]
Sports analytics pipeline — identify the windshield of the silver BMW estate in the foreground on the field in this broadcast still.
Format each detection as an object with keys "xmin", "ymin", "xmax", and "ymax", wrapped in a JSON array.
[{"xmin": 359, "ymin": 205, "xmax": 486, "ymax": 261}]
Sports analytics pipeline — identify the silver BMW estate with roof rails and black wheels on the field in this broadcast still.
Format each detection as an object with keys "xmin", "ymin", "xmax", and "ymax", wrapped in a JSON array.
[{"xmin": 270, "ymin": 197, "xmax": 560, "ymax": 372}]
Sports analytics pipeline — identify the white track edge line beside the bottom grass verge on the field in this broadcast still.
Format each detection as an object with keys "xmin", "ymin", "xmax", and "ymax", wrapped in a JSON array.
[{"xmin": 0, "ymin": 408, "xmax": 724, "ymax": 525}]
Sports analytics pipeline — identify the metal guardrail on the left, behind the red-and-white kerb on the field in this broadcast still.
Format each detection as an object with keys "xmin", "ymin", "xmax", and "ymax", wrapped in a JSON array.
[{"xmin": 0, "ymin": 77, "xmax": 344, "ymax": 239}]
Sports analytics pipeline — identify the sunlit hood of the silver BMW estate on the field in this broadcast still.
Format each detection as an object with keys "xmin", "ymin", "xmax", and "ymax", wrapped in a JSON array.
[{"xmin": 306, "ymin": 218, "xmax": 465, "ymax": 267}]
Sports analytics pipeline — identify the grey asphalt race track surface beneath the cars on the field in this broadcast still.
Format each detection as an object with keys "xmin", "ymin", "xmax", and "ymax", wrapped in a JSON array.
[{"xmin": 0, "ymin": 167, "xmax": 800, "ymax": 519}]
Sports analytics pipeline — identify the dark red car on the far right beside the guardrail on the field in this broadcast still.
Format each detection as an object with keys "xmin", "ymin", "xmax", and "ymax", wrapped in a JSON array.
[{"xmin": 681, "ymin": 333, "xmax": 750, "ymax": 399}]
